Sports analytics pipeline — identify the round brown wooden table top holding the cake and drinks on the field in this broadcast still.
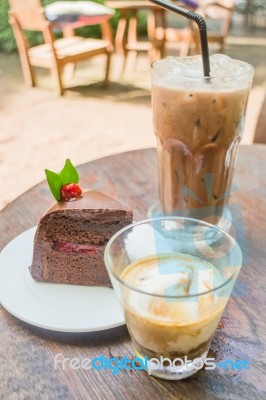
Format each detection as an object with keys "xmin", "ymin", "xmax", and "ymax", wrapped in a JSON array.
[{"xmin": 0, "ymin": 145, "xmax": 266, "ymax": 400}]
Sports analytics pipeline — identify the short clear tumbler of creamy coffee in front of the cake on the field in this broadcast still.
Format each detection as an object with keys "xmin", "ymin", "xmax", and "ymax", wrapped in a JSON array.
[{"xmin": 105, "ymin": 217, "xmax": 242, "ymax": 380}]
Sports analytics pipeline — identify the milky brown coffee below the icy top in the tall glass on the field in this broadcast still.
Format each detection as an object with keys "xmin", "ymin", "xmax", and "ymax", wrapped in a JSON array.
[{"xmin": 152, "ymin": 85, "xmax": 249, "ymax": 222}]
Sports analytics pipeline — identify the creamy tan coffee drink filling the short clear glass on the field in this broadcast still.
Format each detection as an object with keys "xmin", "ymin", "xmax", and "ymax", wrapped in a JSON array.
[{"xmin": 121, "ymin": 254, "xmax": 226, "ymax": 359}]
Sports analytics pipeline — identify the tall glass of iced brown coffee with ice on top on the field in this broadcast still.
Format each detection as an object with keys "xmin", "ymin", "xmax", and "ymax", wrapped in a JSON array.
[{"xmin": 152, "ymin": 55, "xmax": 253, "ymax": 223}]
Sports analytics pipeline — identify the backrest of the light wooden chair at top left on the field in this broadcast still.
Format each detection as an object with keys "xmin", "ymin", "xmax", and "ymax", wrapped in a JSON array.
[{"xmin": 9, "ymin": 0, "xmax": 49, "ymax": 31}]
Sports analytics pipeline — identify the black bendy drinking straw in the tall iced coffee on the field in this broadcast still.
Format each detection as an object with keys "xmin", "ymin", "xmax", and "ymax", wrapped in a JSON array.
[{"xmin": 150, "ymin": 0, "xmax": 210, "ymax": 77}]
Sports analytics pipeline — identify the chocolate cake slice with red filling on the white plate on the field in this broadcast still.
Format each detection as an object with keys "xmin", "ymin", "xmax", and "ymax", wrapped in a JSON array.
[{"xmin": 30, "ymin": 191, "xmax": 133, "ymax": 286}]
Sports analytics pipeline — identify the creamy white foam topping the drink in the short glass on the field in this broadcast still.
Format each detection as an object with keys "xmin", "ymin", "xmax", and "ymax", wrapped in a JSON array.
[{"xmin": 121, "ymin": 254, "xmax": 224, "ymax": 324}]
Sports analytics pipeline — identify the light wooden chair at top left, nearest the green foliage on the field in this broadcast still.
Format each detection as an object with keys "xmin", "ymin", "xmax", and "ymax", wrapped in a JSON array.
[{"xmin": 9, "ymin": 0, "xmax": 113, "ymax": 95}]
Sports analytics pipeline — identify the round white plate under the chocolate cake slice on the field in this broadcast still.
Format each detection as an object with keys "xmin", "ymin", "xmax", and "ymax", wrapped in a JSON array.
[{"xmin": 0, "ymin": 227, "xmax": 125, "ymax": 332}]
